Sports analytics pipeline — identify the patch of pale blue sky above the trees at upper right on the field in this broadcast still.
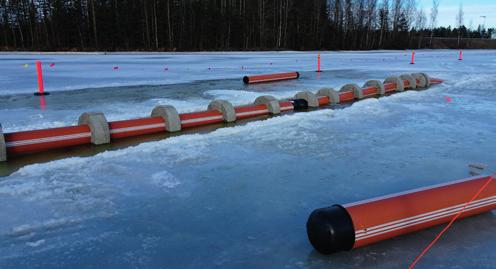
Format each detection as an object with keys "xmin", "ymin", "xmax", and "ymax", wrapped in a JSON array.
[{"xmin": 419, "ymin": 0, "xmax": 496, "ymax": 28}]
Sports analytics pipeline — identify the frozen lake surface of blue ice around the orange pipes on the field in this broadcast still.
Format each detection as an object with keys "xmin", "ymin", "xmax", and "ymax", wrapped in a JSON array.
[{"xmin": 0, "ymin": 50, "xmax": 496, "ymax": 269}]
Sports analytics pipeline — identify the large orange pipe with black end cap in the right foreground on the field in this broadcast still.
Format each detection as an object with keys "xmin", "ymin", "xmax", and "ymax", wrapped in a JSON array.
[{"xmin": 307, "ymin": 176, "xmax": 496, "ymax": 254}]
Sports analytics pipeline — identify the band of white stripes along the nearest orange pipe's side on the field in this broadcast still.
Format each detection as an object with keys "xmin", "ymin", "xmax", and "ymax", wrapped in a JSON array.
[{"xmin": 356, "ymin": 196, "xmax": 496, "ymax": 241}]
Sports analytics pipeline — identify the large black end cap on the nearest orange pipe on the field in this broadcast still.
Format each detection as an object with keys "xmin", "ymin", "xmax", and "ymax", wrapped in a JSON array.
[{"xmin": 307, "ymin": 205, "xmax": 355, "ymax": 254}]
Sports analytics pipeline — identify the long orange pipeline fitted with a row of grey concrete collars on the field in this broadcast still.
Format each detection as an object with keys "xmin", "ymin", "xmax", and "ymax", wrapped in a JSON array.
[{"xmin": 0, "ymin": 73, "xmax": 442, "ymax": 161}]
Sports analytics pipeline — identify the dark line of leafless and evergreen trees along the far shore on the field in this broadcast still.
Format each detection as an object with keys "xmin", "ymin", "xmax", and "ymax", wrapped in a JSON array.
[{"xmin": 0, "ymin": 0, "xmax": 492, "ymax": 51}]
